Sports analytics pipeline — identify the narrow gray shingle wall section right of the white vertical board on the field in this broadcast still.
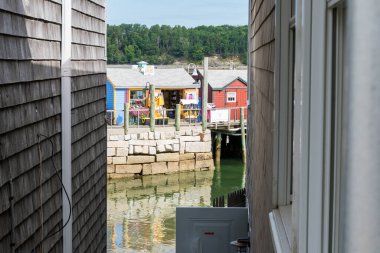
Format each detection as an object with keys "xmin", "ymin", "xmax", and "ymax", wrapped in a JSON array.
[{"xmin": 71, "ymin": 0, "xmax": 107, "ymax": 252}]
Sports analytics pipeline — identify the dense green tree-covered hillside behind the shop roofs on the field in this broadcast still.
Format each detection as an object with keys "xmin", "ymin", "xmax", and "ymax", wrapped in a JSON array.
[{"xmin": 107, "ymin": 24, "xmax": 248, "ymax": 64}]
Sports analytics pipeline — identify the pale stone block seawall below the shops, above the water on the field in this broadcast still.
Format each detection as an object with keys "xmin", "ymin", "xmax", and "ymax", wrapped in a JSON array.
[{"xmin": 107, "ymin": 127, "xmax": 214, "ymax": 178}]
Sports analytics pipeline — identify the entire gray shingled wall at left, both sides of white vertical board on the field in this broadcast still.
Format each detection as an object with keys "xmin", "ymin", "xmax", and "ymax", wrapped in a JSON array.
[{"xmin": 0, "ymin": 0, "xmax": 106, "ymax": 252}]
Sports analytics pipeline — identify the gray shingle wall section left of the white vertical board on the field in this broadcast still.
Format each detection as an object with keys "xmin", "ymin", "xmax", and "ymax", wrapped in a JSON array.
[{"xmin": 0, "ymin": 0, "xmax": 62, "ymax": 252}]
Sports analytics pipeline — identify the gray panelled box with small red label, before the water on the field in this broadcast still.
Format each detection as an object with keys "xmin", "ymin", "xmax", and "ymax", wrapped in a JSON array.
[{"xmin": 176, "ymin": 207, "xmax": 248, "ymax": 253}]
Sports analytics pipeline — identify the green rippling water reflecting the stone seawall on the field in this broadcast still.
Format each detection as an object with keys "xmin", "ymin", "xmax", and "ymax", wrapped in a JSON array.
[{"xmin": 107, "ymin": 160, "xmax": 244, "ymax": 253}]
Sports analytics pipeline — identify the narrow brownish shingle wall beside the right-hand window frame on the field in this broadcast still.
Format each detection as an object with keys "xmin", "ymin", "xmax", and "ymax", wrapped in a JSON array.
[{"xmin": 247, "ymin": 0, "xmax": 275, "ymax": 252}]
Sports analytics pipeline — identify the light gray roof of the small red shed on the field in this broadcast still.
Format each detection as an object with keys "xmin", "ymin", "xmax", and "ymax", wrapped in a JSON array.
[{"xmin": 203, "ymin": 69, "xmax": 247, "ymax": 89}]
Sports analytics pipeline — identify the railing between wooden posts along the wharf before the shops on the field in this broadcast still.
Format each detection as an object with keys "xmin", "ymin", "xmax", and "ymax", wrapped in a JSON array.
[{"xmin": 106, "ymin": 106, "xmax": 247, "ymax": 131}]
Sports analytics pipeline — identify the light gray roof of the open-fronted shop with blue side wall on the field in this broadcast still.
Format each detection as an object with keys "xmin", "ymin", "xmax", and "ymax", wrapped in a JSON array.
[{"xmin": 107, "ymin": 66, "xmax": 200, "ymax": 89}]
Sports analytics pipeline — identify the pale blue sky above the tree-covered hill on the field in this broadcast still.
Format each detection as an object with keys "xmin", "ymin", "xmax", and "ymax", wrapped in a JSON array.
[{"xmin": 107, "ymin": 0, "xmax": 248, "ymax": 27}]
